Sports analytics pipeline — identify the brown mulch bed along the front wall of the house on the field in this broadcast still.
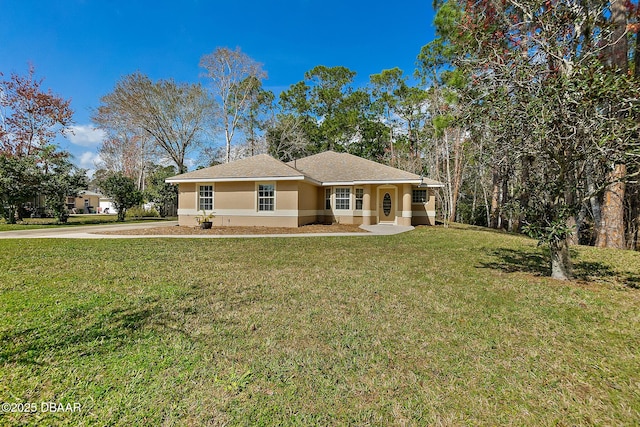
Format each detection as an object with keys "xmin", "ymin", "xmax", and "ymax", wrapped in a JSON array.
[{"xmin": 95, "ymin": 224, "xmax": 367, "ymax": 236}]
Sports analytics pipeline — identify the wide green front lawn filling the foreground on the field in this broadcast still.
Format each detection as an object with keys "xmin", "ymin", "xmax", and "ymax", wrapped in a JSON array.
[{"xmin": 0, "ymin": 228, "xmax": 640, "ymax": 426}]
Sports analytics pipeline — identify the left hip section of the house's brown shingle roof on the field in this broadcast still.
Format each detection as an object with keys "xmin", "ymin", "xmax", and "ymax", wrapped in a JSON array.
[{"xmin": 167, "ymin": 154, "xmax": 304, "ymax": 182}]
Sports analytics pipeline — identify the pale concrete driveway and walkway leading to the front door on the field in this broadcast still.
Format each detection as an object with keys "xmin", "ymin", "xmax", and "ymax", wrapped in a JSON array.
[{"xmin": 0, "ymin": 221, "xmax": 413, "ymax": 239}]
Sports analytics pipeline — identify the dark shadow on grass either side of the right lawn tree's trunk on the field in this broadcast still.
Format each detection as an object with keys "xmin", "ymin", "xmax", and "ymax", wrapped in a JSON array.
[{"xmin": 478, "ymin": 248, "xmax": 640, "ymax": 289}]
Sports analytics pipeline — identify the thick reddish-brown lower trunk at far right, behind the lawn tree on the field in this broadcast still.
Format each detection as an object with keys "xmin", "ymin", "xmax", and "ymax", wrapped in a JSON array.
[{"xmin": 596, "ymin": 163, "xmax": 627, "ymax": 249}]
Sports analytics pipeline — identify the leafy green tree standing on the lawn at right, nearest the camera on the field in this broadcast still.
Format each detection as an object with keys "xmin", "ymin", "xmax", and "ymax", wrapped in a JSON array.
[{"xmin": 427, "ymin": 0, "xmax": 640, "ymax": 279}]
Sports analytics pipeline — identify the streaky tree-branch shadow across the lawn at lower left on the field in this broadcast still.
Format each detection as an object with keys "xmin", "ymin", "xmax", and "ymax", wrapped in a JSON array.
[{"xmin": 0, "ymin": 285, "xmax": 226, "ymax": 365}]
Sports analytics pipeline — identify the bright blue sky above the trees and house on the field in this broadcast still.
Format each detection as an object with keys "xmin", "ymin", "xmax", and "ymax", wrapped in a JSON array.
[{"xmin": 0, "ymin": 0, "xmax": 433, "ymax": 169}]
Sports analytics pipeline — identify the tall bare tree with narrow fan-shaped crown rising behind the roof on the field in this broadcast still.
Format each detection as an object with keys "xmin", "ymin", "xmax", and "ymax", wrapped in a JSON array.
[{"xmin": 200, "ymin": 47, "xmax": 267, "ymax": 163}]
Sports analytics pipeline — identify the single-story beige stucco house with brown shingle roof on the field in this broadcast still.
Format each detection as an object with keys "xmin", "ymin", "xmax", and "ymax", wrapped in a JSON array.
[{"xmin": 166, "ymin": 151, "xmax": 442, "ymax": 227}]
